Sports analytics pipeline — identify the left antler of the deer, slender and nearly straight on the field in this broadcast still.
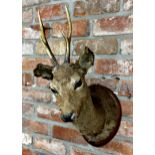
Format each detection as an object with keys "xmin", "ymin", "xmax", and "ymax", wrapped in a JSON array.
[{"xmin": 38, "ymin": 11, "xmax": 58, "ymax": 65}]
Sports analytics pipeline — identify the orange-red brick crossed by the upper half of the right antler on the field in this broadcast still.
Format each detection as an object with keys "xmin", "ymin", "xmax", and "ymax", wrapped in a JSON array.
[{"xmin": 51, "ymin": 20, "xmax": 89, "ymax": 37}]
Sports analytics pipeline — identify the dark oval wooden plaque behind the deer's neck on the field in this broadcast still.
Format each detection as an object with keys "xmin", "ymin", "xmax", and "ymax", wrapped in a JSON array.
[{"xmin": 81, "ymin": 85, "xmax": 122, "ymax": 146}]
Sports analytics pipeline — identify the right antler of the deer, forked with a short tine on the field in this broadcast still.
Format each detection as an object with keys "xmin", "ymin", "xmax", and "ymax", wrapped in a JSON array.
[{"xmin": 62, "ymin": 5, "xmax": 72, "ymax": 63}]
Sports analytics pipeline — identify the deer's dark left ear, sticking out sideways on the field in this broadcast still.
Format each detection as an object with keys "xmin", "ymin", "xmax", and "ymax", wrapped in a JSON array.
[{"xmin": 33, "ymin": 64, "xmax": 53, "ymax": 80}]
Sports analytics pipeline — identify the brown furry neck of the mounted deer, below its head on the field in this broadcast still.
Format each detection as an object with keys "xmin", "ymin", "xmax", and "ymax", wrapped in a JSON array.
[{"xmin": 74, "ymin": 91, "xmax": 105, "ymax": 135}]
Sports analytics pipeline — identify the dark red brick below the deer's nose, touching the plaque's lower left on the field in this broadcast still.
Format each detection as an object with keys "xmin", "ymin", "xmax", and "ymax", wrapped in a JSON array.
[{"xmin": 53, "ymin": 126, "xmax": 87, "ymax": 144}]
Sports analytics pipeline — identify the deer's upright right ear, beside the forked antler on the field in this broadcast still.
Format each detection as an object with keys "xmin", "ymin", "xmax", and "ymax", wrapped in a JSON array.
[{"xmin": 78, "ymin": 47, "xmax": 94, "ymax": 70}]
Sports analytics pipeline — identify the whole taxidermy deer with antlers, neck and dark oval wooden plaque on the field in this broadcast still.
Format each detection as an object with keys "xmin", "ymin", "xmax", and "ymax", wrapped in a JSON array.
[{"xmin": 34, "ymin": 6, "xmax": 121, "ymax": 146}]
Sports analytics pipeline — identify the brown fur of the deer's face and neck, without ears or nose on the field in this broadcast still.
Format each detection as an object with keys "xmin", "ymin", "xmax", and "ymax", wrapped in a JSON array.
[{"xmin": 50, "ymin": 64, "xmax": 104, "ymax": 135}]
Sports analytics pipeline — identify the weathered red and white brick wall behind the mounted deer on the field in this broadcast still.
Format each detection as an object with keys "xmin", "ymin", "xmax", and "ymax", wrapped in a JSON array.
[{"xmin": 22, "ymin": 0, "xmax": 133, "ymax": 155}]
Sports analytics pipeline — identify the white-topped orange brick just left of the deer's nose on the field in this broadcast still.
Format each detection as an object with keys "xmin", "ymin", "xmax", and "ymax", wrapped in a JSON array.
[{"xmin": 37, "ymin": 106, "xmax": 63, "ymax": 122}]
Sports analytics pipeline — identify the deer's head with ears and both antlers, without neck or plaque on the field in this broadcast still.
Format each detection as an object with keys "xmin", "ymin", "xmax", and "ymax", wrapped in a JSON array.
[{"xmin": 34, "ymin": 6, "xmax": 94, "ymax": 121}]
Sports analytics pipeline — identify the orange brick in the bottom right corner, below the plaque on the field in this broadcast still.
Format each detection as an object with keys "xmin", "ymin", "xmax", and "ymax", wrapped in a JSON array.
[{"xmin": 102, "ymin": 140, "xmax": 133, "ymax": 155}]
